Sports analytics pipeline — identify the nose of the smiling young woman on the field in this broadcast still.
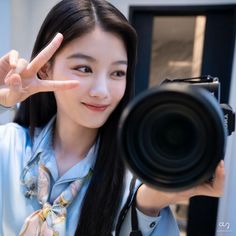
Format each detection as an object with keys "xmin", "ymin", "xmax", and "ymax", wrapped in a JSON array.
[{"xmin": 89, "ymin": 76, "xmax": 109, "ymax": 99}]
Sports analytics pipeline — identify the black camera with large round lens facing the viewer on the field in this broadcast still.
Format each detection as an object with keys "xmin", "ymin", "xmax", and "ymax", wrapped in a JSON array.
[{"xmin": 118, "ymin": 76, "xmax": 235, "ymax": 191}]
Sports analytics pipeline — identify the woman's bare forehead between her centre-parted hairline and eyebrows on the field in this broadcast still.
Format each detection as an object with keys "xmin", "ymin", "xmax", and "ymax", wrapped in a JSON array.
[{"xmin": 57, "ymin": 27, "xmax": 127, "ymax": 60}]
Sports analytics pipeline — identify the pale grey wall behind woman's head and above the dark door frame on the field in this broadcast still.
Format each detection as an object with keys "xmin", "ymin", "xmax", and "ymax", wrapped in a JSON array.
[{"xmin": 7, "ymin": 0, "xmax": 236, "ymax": 59}]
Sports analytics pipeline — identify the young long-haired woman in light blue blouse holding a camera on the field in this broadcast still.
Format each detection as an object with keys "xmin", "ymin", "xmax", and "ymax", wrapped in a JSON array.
[{"xmin": 0, "ymin": 0, "xmax": 224, "ymax": 236}]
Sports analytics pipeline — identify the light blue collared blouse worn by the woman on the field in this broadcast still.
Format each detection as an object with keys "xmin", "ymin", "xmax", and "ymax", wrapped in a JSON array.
[{"xmin": 0, "ymin": 117, "xmax": 179, "ymax": 236}]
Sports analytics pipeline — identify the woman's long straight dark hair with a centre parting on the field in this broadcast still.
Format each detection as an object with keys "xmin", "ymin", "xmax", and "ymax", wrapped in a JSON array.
[{"xmin": 15, "ymin": 0, "xmax": 136, "ymax": 236}]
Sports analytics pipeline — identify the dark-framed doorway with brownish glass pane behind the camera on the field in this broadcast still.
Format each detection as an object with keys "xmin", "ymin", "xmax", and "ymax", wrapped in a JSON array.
[{"xmin": 129, "ymin": 4, "xmax": 236, "ymax": 236}]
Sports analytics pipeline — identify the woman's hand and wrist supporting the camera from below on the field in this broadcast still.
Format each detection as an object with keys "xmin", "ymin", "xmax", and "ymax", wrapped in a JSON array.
[{"xmin": 136, "ymin": 161, "xmax": 225, "ymax": 216}]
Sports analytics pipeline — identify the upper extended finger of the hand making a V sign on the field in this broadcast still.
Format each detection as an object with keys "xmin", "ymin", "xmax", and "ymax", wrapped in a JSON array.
[{"xmin": 27, "ymin": 33, "xmax": 63, "ymax": 73}]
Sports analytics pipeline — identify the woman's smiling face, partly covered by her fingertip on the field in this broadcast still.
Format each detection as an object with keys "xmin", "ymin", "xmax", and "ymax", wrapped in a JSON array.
[{"xmin": 48, "ymin": 27, "xmax": 127, "ymax": 128}]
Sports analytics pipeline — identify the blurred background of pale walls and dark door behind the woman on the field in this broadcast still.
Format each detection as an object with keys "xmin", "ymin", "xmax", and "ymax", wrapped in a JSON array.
[{"xmin": 0, "ymin": 0, "xmax": 236, "ymax": 236}]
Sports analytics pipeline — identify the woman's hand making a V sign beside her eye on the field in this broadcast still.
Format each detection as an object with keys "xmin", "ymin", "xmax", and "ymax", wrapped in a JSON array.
[{"xmin": 0, "ymin": 33, "xmax": 79, "ymax": 107}]
